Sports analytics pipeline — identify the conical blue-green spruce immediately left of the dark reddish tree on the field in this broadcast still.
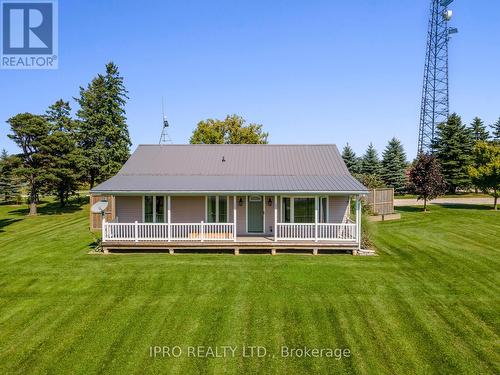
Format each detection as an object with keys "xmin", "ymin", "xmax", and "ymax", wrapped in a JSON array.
[{"xmin": 381, "ymin": 138, "xmax": 407, "ymax": 194}]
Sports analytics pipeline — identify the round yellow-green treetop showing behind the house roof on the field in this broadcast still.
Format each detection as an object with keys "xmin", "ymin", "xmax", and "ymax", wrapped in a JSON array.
[{"xmin": 189, "ymin": 115, "xmax": 269, "ymax": 144}]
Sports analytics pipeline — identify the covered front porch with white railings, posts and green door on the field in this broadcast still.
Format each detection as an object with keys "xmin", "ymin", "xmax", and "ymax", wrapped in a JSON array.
[{"xmin": 97, "ymin": 194, "xmax": 361, "ymax": 253}]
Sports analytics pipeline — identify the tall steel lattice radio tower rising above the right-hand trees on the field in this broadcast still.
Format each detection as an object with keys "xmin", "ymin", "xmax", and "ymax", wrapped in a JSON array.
[{"xmin": 418, "ymin": 0, "xmax": 458, "ymax": 153}]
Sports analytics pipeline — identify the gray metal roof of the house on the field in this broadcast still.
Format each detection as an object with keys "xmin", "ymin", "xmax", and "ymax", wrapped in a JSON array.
[{"xmin": 92, "ymin": 145, "xmax": 366, "ymax": 193}]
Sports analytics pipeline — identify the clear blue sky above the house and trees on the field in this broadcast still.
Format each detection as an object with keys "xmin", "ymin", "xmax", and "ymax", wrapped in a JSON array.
[{"xmin": 0, "ymin": 0, "xmax": 500, "ymax": 159}]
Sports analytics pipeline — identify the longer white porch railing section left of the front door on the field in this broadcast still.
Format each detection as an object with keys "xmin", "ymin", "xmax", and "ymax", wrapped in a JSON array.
[{"xmin": 102, "ymin": 222, "xmax": 235, "ymax": 242}]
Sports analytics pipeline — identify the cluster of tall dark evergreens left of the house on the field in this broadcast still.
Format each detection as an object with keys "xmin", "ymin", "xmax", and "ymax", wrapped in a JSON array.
[{"xmin": 0, "ymin": 62, "xmax": 131, "ymax": 215}]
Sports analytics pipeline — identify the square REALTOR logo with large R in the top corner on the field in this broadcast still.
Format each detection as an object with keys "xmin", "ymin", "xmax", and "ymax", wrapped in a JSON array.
[{"xmin": 0, "ymin": 0, "xmax": 58, "ymax": 69}]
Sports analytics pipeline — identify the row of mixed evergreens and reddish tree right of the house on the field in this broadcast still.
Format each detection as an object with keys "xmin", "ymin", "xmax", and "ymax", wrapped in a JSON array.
[{"xmin": 342, "ymin": 113, "xmax": 500, "ymax": 209}]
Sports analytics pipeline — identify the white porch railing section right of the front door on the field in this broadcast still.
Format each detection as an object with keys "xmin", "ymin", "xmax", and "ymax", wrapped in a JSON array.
[{"xmin": 276, "ymin": 223, "xmax": 358, "ymax": 242}]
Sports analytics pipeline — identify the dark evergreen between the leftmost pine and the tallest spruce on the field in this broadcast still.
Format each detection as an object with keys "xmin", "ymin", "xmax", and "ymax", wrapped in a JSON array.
[{"xmin": 42, "ymin": 99, "xmax": 83, "ymax": 206}]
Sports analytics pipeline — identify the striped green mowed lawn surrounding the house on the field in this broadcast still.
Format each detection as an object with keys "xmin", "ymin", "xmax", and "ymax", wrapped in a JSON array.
[{"xmin": 0, "ymin": 201, "xmax": 500, "ymax": 374}]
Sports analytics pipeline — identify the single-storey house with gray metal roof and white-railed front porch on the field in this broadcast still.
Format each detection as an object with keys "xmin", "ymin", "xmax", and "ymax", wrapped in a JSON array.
[{"xmin": 91, "ymin": 145, "xmax": 367, "ymax": 254}]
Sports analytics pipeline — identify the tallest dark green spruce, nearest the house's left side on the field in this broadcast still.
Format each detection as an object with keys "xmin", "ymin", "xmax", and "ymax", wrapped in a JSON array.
[{"xmin": 75, "ymin": 62, "xmax": 131, "ymax": 188}]
